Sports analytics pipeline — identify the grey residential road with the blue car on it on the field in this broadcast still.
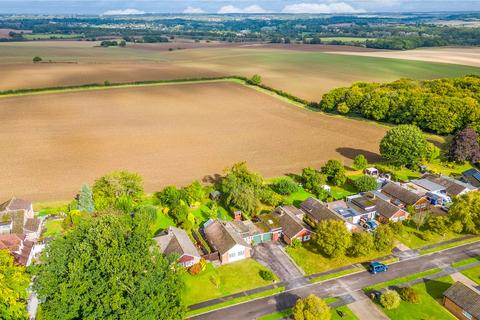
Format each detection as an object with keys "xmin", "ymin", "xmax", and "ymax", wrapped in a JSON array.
[{"xmin": 190, "ymin": 242, "xmax": 480, "ymax": 320}]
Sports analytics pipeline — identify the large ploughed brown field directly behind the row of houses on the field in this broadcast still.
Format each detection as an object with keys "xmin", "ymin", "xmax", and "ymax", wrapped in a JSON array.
[{"xmin": 0, "ymin": 82, "xmax": 386, "ymax": 200}]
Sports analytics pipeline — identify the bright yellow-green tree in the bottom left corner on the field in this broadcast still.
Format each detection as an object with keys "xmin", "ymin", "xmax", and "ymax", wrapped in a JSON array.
[{"xmin": 0, "ymin": 250, "xmax": 30, "ymax": 320}]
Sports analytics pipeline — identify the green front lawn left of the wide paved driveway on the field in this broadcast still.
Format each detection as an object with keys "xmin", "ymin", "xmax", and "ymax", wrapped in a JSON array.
[{"xmin": 184, "ymin": 259, "xmax": 278, "ymax": 305}]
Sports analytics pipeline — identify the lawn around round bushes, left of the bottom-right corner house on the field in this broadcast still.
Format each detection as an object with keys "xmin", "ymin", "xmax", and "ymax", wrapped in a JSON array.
[{"xmin": 380, "ymin": 276, "xmax": 456, "ymax": 320}]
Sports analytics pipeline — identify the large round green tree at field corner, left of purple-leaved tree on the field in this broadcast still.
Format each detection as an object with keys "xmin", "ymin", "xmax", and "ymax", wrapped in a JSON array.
[{"xmin": 380, "ymin": 125, "xmax": 427, "ymax": 166}]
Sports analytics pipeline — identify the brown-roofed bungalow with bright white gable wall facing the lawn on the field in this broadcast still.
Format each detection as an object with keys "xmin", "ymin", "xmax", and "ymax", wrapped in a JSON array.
[{"xmin": 204, "ymin": 220, "xmax": 252, "ymax": 264}]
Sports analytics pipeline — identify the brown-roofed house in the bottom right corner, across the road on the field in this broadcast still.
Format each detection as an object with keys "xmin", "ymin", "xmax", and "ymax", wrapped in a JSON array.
[{"xmin": 443, "ymin": 282, "xmax": 480, "ymax": 320}]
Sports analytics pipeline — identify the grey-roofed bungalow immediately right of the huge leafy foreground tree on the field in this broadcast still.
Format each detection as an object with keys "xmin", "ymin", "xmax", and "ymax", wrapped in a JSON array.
[{"xmin": 154, "ymin": 227, "xmax": 201, "ymax": 268}]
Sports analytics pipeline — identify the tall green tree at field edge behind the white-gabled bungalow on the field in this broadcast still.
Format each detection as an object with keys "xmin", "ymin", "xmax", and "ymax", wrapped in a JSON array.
[{"xmin": 219, "ymin": 162, "xmax": 263, "ymax": 216}]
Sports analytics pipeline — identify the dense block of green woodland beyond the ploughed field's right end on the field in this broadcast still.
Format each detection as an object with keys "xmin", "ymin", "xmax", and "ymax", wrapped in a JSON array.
[{"xmin": 319, "ymin": 75, "xmax": 480, "ymax": 134}]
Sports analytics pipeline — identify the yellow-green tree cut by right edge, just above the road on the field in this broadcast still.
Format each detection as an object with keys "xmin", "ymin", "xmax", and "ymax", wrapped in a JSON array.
[{"xmin": 448, "ymin": 192, "xmax": 480, "ymax": 234}]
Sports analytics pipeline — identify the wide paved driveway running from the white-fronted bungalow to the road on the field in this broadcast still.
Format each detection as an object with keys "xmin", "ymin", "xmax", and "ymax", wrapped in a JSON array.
[{"xmin": 253, "ymin": 242, "xmax": 303, "ymax": 282}]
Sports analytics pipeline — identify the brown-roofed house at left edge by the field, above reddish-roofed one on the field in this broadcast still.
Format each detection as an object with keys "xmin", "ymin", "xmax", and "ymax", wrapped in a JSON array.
[{"xmin": 0, "ymin": 197, "xmax": 42, "ymax": 241}]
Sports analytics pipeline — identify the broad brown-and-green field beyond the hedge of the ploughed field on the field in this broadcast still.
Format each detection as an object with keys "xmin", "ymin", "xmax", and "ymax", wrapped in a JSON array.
[{"xmin": 0, "ymin": 41, "xmax": 480, "ymax": 101}]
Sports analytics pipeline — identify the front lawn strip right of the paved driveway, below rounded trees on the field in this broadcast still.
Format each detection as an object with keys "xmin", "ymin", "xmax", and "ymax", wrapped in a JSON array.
[{"xmin": 286, "ymin": 243, "xmax": 390, "ymax": 274}]
